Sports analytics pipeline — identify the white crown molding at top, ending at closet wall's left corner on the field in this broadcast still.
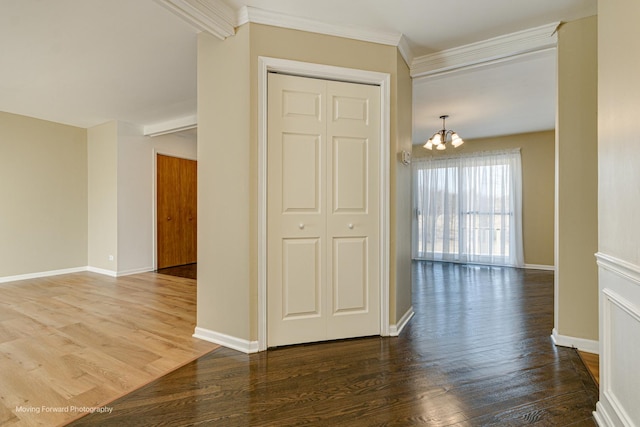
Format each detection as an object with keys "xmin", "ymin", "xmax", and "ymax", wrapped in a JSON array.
[{"xmin": 154, "ymin": 0, "xmax": 236, "ymax": 40}]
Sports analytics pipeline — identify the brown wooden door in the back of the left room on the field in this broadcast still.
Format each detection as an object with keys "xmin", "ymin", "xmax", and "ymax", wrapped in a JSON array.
[{"xmin": 156, "ymin": 154, "xmax": 198, "ymax": 268}]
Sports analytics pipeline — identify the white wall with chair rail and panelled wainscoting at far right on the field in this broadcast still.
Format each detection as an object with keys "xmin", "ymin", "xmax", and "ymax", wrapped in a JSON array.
[{"xmin": 595, "ymin": 0, "xmax": 640, "ymax": 426}]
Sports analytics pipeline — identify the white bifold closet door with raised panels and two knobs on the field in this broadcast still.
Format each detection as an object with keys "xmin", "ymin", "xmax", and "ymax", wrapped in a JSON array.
[{"xmin": 267, "ymin": 73, "xmax": 381, "ymax": 346}]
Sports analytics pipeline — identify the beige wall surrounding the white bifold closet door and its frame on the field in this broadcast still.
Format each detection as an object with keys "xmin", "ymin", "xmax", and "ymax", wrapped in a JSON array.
[{"xmin": 198, "ymin": 24, "xmax": 411, "ymax": 341}]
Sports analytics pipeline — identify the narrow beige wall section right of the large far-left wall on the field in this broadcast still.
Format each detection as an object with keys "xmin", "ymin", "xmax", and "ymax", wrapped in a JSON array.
[{"xmin": 87, "ymin": 121, "xmax": 118, "ymax": 273}]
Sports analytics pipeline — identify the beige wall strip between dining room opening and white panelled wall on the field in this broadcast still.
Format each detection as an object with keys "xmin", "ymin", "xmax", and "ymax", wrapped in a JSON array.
[{"xmin": 555, "ymin": 16, "xmax": 598, "ymax": 345}]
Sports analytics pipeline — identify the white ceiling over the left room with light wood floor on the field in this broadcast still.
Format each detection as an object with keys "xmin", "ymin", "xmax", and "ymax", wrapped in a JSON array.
[{"xmin": 0, "ymin": 0, "xmax": 197, "ymax": 127}]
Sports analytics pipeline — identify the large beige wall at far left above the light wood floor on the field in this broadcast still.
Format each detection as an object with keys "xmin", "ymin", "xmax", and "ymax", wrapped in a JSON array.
[{"xmin": 0, "ymin": 112, "xmax": 87, "ymax": 279}]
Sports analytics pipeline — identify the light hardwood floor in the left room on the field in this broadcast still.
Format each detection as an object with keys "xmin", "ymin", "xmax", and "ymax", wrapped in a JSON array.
[{"xmin": 0, "ymin": 272, "xmax": 218, "ymax": 426}]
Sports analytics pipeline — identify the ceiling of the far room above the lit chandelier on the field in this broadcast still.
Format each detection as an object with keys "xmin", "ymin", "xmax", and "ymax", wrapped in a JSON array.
[{"xmin": 413, "ymin": 50, "xmax": 556, "ymax": 144}]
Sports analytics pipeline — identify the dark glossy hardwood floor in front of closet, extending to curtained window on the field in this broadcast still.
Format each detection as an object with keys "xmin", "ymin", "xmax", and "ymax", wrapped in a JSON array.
[{"xmin": 67, "ymin": 262, "xmax": 598, "ymax": 426}]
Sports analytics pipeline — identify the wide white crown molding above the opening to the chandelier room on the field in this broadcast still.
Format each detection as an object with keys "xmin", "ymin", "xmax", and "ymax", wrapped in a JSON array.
[{"xmin": 410, "ymin": 22, "xmax": 560, "ymax": 78}]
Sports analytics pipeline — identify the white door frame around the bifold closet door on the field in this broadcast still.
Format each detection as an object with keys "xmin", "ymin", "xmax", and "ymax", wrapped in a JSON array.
[{"xmin": 258, "ymin": 56, "xmax": 391, "ymax": 351}]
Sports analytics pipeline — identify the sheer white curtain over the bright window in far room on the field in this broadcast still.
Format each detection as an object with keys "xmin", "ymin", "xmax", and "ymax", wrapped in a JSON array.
[{"xmin": 413, "ymin": 149, "xmax": 524, "ymax": 267}]
